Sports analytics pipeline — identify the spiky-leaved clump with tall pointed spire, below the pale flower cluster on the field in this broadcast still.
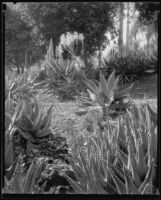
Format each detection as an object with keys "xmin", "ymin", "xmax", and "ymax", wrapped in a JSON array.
[{"xmin": 37, "ymin": 39, "xmax": 81, "ymax": 100}]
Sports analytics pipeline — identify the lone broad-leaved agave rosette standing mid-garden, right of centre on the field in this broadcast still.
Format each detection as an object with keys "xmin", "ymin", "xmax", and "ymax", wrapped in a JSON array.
[{"xmin": 79, "ymin": 71, "xmax": 133, "ymax": 118}]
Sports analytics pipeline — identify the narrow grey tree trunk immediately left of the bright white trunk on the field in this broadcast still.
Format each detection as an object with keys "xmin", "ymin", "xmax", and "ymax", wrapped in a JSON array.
[{"xmin": 119, "ymin": 2, "xmax": 124, "ymax": 57}]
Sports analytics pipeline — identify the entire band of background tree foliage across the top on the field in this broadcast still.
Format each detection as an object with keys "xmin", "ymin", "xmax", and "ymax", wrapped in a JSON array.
[{"xmin": 5, "ymin": 2, "xmax": 159, "ymax": 72}]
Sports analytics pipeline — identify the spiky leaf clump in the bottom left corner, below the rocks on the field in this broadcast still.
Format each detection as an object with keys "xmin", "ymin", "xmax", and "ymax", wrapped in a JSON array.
[{"xmin": 3, "ymin": 155, "xmax": 54, "ymax": 194}]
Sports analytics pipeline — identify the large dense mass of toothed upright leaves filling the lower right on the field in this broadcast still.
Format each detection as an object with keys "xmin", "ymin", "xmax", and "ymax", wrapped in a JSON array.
[{"xmin": 67, "ymin": 104, "xmax": 158, "ymax": 194}]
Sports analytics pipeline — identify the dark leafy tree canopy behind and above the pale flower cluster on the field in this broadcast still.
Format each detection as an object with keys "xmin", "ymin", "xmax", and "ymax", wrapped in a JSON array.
[{"xmin": 17, "ymin": 2, "xmax": 117, "ymax": 55}]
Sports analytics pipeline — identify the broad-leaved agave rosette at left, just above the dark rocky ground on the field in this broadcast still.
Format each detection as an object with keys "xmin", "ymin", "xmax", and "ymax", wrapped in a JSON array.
[{"xmin": 10, "ymin": 98, "xmax": 52, "ymax": 142}]
